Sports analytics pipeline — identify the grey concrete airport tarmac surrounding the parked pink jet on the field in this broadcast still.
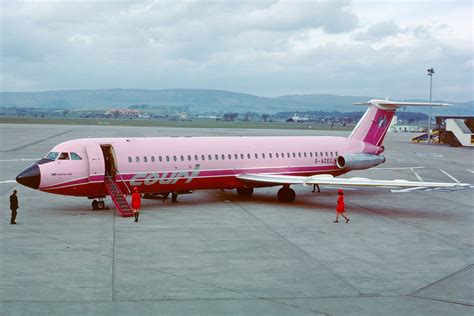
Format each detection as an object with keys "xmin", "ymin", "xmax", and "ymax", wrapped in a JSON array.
[{"xmin": 0, "ymin": 124, "xmax": 474, "ymax": 315}]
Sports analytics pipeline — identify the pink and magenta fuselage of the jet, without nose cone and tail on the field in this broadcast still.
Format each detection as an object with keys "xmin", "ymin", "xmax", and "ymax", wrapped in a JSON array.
[{"xmin": 25, "ymin": 136, "xmax": 381, "ymax": 197}]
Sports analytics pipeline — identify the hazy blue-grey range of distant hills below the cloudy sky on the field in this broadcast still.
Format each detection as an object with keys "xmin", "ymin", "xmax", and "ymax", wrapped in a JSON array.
[{"xmin": 0, "ymin": 89, "xmax": 474, "ymax": 115}]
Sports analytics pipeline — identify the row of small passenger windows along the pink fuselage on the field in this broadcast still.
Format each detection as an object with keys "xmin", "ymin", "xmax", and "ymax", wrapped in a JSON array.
[{"xmin": 128, "ymin": 151, "xmax": 337, "ymax": 163}]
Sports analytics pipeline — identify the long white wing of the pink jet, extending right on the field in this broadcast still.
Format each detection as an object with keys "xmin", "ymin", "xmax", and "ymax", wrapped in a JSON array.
[{"xmin": 237, "ymin": 174, "xmax": 470, "ymax": 189}]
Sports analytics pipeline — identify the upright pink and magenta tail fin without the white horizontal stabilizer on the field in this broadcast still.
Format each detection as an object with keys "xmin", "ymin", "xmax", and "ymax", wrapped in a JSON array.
[{"xmin": 349, "ymin": 106, "xmax": 395, "ymax": 146}]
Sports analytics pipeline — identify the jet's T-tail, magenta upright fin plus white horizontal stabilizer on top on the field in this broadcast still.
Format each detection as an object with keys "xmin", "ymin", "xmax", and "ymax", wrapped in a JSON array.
[{"xmin": 349, "ymin": 99, "xmax": 450, "ymax": 146}]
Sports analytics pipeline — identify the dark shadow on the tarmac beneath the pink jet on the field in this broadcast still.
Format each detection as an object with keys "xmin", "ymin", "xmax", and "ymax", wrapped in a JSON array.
[{"xmin": 56, "ymin": 190, "xmax": 459, "ymax": 220}]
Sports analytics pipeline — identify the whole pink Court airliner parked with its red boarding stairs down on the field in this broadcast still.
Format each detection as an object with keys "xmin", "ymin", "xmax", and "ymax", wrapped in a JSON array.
[{"xmin": 16, "ymin": 100, "xmax": 469, "ymax": 216}]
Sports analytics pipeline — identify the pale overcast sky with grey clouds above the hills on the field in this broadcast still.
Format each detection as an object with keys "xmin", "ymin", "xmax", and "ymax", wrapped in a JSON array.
[{"xmin": 0, "ymin": 0, "xmax": 474, "ymax": 101}]
